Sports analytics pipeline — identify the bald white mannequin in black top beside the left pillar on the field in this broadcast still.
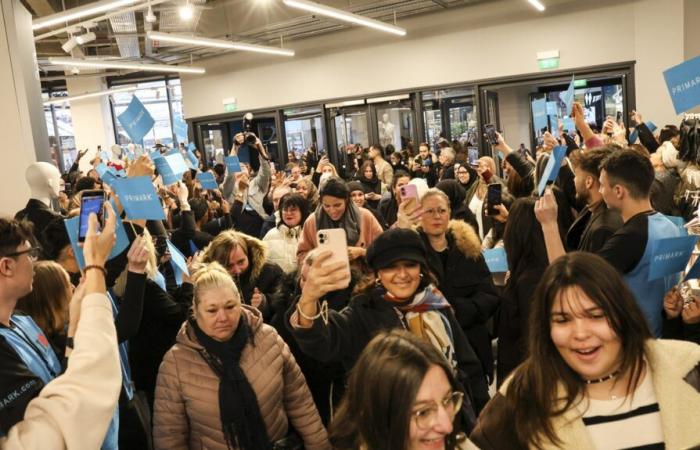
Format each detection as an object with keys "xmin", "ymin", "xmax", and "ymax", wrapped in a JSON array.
[{"xmin": 15, "ymin": 162, "xmax": 61, "ymax": 242}]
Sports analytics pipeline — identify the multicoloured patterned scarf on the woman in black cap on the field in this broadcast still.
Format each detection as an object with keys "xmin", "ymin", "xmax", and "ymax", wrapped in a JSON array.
[{"xmin": 376, "ymin": 284, "xmax": 457, "ymax": 368}]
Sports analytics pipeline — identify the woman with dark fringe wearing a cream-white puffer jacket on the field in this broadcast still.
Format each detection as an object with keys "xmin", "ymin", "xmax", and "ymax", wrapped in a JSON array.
[{"xmin": 263, "ymin": 193, "xmax": 309, "ymax": 273}]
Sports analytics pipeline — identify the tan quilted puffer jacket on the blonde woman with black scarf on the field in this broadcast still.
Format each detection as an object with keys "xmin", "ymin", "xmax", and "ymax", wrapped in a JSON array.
[{"xmin": 153, "ymin": 305, "xmax": 330, "ymax": 450}]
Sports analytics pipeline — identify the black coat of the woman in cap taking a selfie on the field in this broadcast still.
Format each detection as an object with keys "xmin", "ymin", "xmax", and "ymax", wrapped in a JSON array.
[{"xmin": 285, "ymin": 288, "xmax": 489, "ymax": 413}]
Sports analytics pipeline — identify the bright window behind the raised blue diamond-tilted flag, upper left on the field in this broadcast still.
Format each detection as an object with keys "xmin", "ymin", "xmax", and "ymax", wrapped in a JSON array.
[{"xmin": 112, "ymin": 80, "xmax": 186, "ymax": 148}]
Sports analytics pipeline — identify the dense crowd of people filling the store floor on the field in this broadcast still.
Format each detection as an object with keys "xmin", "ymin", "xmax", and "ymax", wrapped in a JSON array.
[{"xmin": 0, "ymin": 103, "xmax": 700, "ymax": 450}]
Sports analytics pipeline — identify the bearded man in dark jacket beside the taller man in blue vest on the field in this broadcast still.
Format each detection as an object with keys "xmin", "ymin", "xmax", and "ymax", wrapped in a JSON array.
[{"xmin": 566, "ymin": 147, "xmax": 622, "ymax": 253}]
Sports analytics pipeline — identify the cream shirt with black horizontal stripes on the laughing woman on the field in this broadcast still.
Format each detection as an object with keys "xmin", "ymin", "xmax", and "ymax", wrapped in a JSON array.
[{"xmin": 582, "ymin": 371, "xmax": 666, "ymax": 450}]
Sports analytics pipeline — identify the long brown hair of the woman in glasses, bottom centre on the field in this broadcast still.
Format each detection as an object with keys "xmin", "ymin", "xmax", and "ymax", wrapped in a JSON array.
[{"xmin": 329, "ymin": 330, "xmax": 460, "ymax": 450}]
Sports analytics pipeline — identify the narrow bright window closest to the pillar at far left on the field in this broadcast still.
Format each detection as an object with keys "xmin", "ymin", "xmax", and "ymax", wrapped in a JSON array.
[{"xmin": 42, "ymin": 90, "xmax": 77, "ymax": 171}]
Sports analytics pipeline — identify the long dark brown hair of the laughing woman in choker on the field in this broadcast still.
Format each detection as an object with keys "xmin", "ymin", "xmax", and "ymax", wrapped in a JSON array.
[{"xmin": 506, "ymin": 251, "xmax": 652, "ymax": 448}]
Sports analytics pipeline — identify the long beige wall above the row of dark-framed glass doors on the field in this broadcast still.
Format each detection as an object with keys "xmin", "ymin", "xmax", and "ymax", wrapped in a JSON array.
[{"xmin": 183, "ymin": 0, "xmax": 697, "ymax": 128}]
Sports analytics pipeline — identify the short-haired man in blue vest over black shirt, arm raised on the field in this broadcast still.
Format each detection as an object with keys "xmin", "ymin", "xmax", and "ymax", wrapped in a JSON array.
[{"xmin": 535, "ymin": 148, "xmax": 680, "ymax": 337}]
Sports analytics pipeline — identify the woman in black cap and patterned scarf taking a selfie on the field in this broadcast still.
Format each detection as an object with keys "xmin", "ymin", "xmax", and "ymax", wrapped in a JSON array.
[{"xmin": 288, "ymin": 228, "xmax": 488, "ymax": 411}]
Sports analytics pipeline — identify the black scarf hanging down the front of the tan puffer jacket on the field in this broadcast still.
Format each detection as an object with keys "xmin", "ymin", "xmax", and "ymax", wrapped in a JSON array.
[{"xmin": 190, "ymin": 316, "xmax": 272, "ymax": 450}]
